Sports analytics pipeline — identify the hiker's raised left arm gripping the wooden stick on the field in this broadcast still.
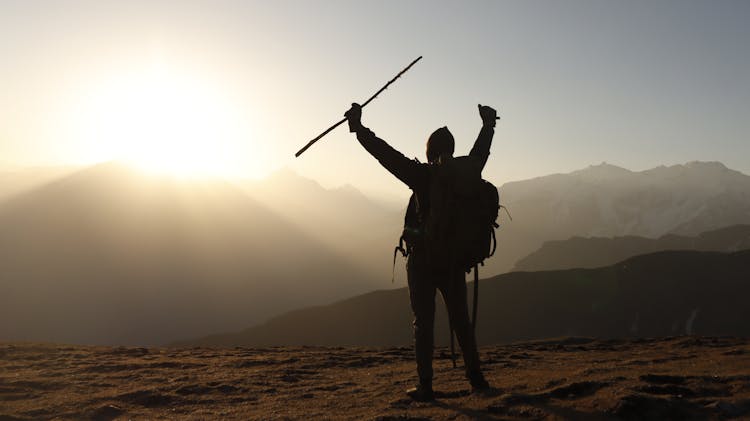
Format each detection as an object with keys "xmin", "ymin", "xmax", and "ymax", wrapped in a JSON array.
[{"xmin": 344, "ymin": 104, "xmax": 423, "ymax": 187}]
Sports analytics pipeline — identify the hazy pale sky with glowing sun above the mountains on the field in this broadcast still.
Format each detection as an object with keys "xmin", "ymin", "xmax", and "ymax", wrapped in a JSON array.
[{"xmin": 0, "ymin": 0, "xmax": 750, "ymax": 195}]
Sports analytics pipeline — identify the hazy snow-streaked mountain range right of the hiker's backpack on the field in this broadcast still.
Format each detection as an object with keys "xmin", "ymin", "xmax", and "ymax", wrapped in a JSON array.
[{"xmin": 485, "ymin": 162, "xmax": 750, "ymax": 275}]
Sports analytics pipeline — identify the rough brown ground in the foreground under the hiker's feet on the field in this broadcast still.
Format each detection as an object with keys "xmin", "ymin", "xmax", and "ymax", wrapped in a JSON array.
[{"xmin": 0, "ymin": 337, "xmax": 750, "ymax": 420}]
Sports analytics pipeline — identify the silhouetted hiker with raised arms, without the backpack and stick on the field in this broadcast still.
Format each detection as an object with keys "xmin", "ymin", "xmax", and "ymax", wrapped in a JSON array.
[{"xmin": 344, "ymin": 104, "xmax": 497, "ymax": 401}]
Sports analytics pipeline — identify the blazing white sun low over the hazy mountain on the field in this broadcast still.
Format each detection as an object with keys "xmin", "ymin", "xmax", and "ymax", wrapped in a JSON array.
[{"xmin": 74, "ymin": 67, "xmax": 259, "ymax": 177}]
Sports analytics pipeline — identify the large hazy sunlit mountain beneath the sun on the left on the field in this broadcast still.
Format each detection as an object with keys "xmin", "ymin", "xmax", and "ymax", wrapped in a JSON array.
[{"xmin": 0, "ymin": 163, "xmax": 383, "ymax": 345}]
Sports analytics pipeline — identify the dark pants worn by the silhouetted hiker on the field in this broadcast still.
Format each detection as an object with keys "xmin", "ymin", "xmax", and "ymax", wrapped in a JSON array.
[{"xmin": 407, "ymin": 249, "xmax": 479, "ymax": 382}]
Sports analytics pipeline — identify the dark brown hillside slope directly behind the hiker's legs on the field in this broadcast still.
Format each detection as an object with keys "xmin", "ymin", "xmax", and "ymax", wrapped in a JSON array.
[{"xmin": 182, "ymin": 250, "xmax": 750, "ymax": 346}]
